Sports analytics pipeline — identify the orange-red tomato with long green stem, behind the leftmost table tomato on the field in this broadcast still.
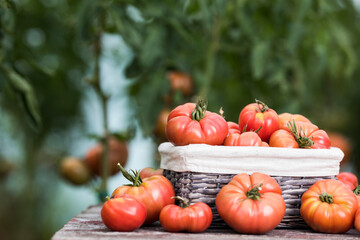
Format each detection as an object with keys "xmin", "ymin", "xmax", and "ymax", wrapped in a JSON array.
[{"xmin": 111, "ymin": 165, "xmax": 175, "ymax": 225}]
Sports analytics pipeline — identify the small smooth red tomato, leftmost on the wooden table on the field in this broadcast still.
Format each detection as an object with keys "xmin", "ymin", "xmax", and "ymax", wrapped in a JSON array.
[{"xmin": 101, "ymin": 195, "xmax": 146, "ymax": 232}]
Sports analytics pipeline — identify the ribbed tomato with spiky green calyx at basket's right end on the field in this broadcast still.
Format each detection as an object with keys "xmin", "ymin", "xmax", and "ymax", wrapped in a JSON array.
[{"xmin": 269, "ymin": 121, "xmax": 331, "ymax": 149}]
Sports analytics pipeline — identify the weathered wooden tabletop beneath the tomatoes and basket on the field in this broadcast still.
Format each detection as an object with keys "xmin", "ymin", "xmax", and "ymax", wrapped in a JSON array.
[{"xmin": 52, "ymin": 205, "xmax": 360, "ymax": 240}]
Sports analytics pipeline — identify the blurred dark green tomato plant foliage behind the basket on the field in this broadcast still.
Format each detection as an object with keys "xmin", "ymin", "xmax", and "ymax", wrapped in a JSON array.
[{"xmin": 0, "ymin": 0, "xmax": 360, "ymax": 239}]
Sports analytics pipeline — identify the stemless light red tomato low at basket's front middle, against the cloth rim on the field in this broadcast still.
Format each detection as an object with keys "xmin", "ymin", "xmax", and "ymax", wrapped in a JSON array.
[{"xmin": 224, "ymin": 132, "xmax": 262, "ymax": 147}]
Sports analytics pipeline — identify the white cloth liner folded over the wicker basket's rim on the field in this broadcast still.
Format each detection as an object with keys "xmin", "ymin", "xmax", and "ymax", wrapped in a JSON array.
[{"xmin": 159, "ymin": 142, "xmax": 344, "ymax": 177}]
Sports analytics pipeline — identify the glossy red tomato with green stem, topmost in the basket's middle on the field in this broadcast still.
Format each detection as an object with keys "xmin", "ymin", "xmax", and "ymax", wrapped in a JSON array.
[{"xmin": 239, "ymin": 100, "xmax": 280, "ymax": 142}]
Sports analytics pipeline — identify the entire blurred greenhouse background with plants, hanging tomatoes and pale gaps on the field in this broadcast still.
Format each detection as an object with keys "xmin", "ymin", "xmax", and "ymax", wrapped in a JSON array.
[{"xmin": 0, "ymin": 0, "xmax": 360, "ymax": 239}]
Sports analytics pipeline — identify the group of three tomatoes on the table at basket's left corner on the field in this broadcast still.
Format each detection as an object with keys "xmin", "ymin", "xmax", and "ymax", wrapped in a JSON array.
[{"xmin": 101, "ymin": 165, "xmax": 212, "ymax": 232}]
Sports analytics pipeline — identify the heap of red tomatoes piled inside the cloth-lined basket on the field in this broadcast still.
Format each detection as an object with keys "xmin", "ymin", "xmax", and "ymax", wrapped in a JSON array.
[{"xmin": 166, "ymin": 100, "xmax": 331, "ymax": 149}]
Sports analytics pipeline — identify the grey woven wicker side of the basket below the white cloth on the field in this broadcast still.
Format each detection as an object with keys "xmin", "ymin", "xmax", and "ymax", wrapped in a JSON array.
[{"xmin": 164, "ymin": 169, "xmax": 335, "ymax": 228}]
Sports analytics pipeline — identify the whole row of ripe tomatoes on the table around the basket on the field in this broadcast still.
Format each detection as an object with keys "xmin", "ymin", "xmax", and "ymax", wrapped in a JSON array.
[{"xmin": 101, "ymin": 167, "xmax": 360, "ymax": 234}]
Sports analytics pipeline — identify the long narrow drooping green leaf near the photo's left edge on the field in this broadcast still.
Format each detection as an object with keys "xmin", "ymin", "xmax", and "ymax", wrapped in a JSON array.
[{"xmin": 3, "ymin": 67, "xmax": 41, "ymax": 129}]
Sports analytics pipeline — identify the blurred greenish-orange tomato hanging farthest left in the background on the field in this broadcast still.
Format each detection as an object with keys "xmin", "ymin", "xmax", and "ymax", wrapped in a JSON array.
[{"xmin": 59, "ymin": 157, "xmax": 91, "ymax": 185}]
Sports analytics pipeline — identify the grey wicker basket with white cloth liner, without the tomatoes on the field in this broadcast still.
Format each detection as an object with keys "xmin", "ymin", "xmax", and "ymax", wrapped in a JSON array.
[{"xmin": 159, "ymin": 143, "xmax": 343, "ymax": 228}]
